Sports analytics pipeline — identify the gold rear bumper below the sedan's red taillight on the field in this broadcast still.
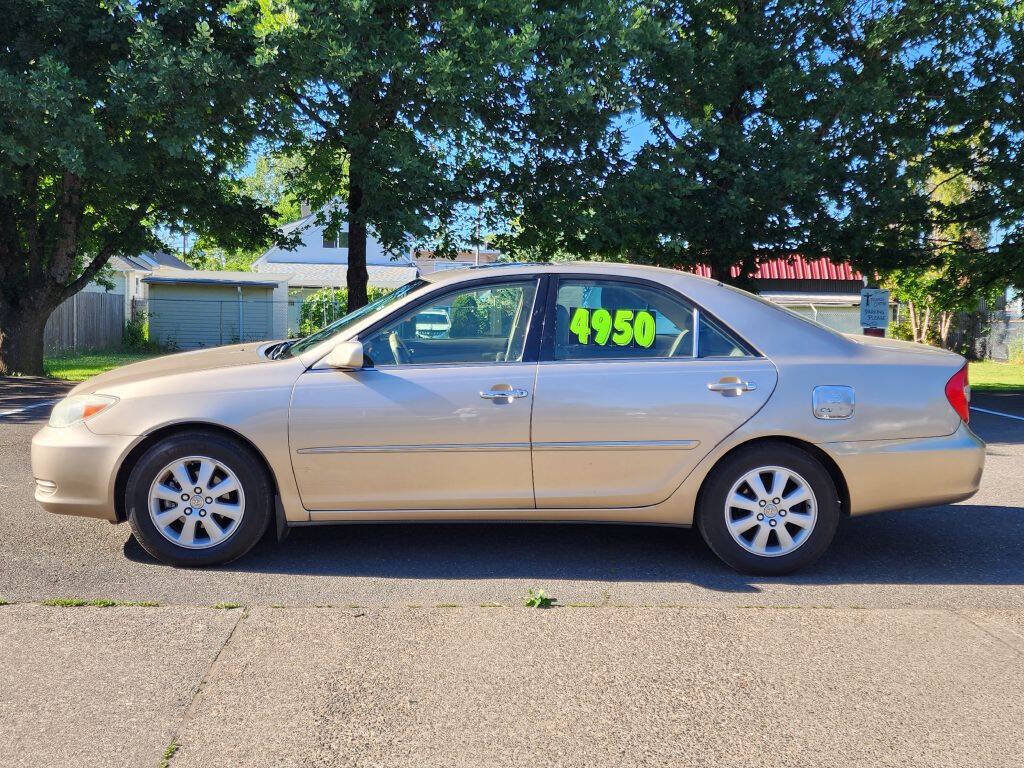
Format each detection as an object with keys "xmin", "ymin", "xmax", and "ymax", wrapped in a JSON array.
[{"xmin": 820, "ymin": 423, "xmax": 985, "ymax": 515}]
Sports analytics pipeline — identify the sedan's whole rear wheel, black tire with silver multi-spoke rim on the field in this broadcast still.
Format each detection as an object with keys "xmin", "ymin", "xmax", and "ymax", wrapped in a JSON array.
[{"xmin": 697, "ymin": 442, "xmax": 840, "ymax": 575}]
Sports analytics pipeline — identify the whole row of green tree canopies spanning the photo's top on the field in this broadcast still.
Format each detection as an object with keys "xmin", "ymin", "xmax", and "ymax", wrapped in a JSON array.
[{"xmin": 0, "ymin": 0, "xmax": 1024, "ymax": 373}]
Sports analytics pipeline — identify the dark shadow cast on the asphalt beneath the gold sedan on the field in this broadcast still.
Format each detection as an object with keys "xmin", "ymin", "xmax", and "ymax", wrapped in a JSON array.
[{"xmin": 124, "ymin": 504, "xmax": 1024, "ymax": 593}]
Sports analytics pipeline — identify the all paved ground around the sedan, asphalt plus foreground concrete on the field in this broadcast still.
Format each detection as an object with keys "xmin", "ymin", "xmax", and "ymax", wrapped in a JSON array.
[{"xmin": 0, "ymin": 380, "xmax": 1024, "ymax": 768}]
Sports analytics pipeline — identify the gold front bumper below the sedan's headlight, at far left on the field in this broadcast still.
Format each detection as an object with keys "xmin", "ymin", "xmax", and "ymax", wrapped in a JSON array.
[{"xmin": 32, "ymin": 422, "xmax": 138, "ymax": 522}]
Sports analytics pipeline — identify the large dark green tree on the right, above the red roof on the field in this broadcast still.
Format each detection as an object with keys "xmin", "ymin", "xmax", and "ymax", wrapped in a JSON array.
[{"xmin": 503, "ymin": 0, "xmax": 1024, "ymax": 290}]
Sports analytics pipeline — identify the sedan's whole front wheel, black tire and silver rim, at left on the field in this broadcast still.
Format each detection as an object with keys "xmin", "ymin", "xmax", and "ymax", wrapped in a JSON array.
[{"xmin": 125, "ymin": 432, "xmax": 272, "ymax": 565}]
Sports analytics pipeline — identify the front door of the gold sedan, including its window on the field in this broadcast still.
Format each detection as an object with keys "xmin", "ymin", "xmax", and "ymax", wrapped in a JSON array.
[{"xmin": 290, "ymin": 280, "xmax": 538, "ymax": 510}]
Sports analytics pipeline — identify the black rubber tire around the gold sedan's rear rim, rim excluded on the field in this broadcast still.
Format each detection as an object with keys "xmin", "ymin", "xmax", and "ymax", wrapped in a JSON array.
[{"xmin": 697, "ymin": 442, "xmax": 840, "ymax": 575}]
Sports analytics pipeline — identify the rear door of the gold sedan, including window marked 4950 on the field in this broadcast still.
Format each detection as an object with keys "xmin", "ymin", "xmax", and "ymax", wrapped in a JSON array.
[{"xmin": 531, "ymin": 275, "xmax": 776, "ymax": 509}]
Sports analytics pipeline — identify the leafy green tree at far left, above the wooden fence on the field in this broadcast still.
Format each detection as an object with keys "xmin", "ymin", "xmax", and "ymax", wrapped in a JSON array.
[{"xmin": 0, "ymin": 0, "xmax": 284, "ymax": 374}]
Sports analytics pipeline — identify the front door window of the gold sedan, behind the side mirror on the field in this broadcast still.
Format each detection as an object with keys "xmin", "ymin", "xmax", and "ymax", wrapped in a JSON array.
[{"xmin": 361, "ymin": 281, "xmax": 537, "ymax": 366}]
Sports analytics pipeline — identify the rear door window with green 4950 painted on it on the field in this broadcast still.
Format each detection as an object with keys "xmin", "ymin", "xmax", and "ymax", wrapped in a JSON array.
[{"xmin": 554, "ymin": 280, "xmax": 694, "ymax": 360}]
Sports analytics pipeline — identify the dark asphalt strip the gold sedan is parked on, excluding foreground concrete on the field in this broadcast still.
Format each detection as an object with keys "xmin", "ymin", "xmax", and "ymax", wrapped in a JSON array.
[{"xmin": 0, "ymin": 380, "xmax": 1024, "ymax": 609}]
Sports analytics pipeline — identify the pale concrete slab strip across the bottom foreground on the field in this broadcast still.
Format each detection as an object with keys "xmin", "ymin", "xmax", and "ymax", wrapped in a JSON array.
[{"xmin": 0, "ymin": 604, "xmax": 1024, "ymax": 768}]
